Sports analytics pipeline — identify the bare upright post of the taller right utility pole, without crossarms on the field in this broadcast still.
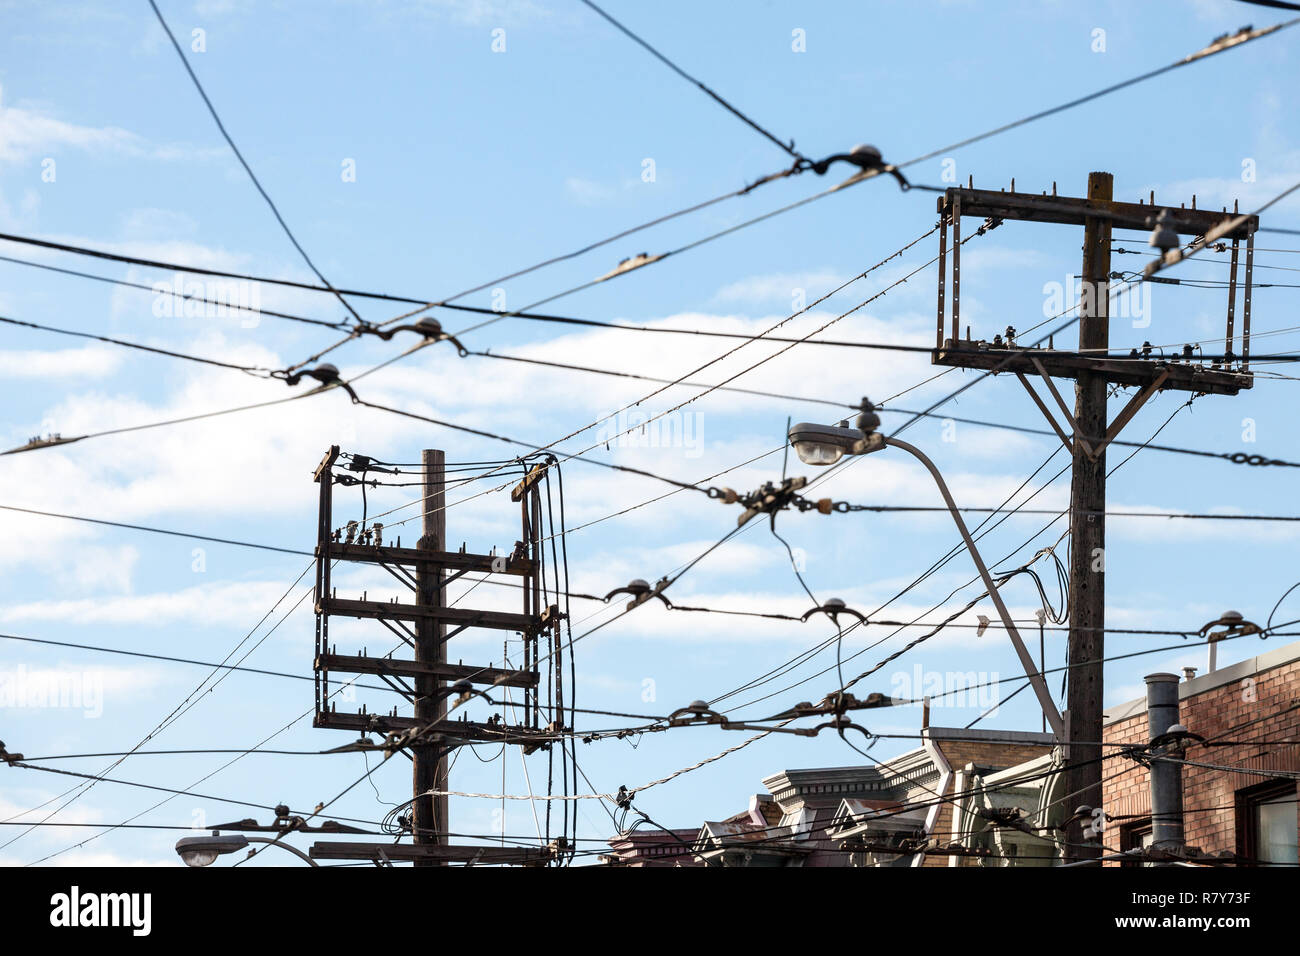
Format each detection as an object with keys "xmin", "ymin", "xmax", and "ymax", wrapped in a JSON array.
[{"xmin": 1065, "ymin": 173, "xmax": 1114, "ymax": 858}]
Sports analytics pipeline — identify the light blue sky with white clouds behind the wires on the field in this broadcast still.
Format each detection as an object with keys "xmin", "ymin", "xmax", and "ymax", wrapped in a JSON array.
[{"xmin": 0, "ymin": 0, "xmax": 1300, "ymax": 865}]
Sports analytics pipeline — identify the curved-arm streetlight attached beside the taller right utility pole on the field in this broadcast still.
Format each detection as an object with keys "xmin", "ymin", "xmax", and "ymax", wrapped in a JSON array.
[{"xmin": 788, "ymin": 398, "xmax": 1065, "ymax": 740}]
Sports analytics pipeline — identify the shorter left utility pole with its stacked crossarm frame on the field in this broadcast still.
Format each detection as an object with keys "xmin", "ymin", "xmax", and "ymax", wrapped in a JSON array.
[{"xmin": 311, "ymin": 445, "xmax": 563, "ymax": 866}]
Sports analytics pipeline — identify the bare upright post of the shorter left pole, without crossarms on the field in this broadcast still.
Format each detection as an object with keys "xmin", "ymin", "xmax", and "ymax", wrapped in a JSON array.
[{"xmin": 411, "ymin": 449, "xmax": 450, "ymax": 866}]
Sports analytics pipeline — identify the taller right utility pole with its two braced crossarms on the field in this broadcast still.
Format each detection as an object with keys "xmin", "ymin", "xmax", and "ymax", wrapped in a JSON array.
[{"xmin": 932, "ymin": 173, "xmax": 1260, "ymax": 860}]
